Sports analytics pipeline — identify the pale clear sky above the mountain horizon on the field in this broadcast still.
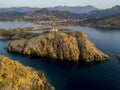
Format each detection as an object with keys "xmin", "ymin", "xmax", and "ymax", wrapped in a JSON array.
[{"xmin": 0, "ymin": 0, "xmax": 120, "ymax": 9}]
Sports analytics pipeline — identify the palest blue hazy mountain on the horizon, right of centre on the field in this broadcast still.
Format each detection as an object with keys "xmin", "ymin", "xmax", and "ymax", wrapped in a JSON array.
[{"xmin": 48, "ymin": 5, "xmax": 98, "ymax": 14}]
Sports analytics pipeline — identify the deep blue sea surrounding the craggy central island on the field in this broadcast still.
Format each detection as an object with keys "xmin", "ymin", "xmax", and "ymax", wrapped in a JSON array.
[{"xmin": 0, "ymin": 24, "xmax": 120, "ymax": 90}]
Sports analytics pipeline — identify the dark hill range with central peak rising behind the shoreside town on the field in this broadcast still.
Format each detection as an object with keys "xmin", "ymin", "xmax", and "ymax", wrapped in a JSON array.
[{"xmin": 0, "ymin": 8, "xmax": 79, "ymax": 21}]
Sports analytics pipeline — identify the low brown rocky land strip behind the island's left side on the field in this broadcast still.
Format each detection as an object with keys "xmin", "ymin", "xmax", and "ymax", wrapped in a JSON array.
[{"xmin": 0, "ymin": 25, "xmax": 69, "ymax": 40}]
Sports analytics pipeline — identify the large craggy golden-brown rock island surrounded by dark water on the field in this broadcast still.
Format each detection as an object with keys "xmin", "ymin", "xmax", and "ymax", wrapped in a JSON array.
[{"xmin": 6, "ymin": 32, "xmax": 109, "ymax": 61}]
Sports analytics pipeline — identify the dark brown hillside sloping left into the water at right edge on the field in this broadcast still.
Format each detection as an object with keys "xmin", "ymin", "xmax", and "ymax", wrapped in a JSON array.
[{"xmin": 84, "ymin": 14, "xmax": 120, "ymax": 29}]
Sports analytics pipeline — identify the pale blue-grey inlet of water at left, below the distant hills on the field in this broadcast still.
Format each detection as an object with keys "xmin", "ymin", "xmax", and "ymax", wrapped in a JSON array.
[{"xmin": 0, "ymin": 21, "xmax": 34, "ymax": 29}]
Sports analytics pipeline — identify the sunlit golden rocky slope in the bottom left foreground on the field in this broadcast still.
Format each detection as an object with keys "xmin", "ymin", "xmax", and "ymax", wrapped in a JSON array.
[{"xmin": 0, "ymin": 55, "xmax": 54, "ymax": 90}]
